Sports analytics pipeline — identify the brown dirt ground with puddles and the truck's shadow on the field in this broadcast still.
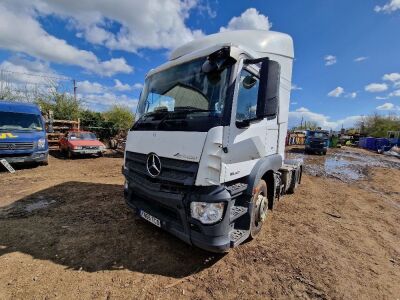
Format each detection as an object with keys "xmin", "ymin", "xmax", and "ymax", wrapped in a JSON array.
[{"xmin": 0, "ymin": 148, "xmax": 400, "ymax": 299}]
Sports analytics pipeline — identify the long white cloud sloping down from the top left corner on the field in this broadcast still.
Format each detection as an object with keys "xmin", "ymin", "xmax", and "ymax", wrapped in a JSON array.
[{"xmin": 0, "ymin": 0, "xmax": 133, "ymax": 76}]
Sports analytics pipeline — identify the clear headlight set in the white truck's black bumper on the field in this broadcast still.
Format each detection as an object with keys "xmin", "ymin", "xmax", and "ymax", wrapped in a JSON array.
[{"xmin": 190, "ymin": 202, "xmax": 225, "ymax": 224}]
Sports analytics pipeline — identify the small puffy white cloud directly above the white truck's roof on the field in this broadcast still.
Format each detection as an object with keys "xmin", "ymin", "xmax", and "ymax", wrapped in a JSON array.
[{"xmin": 220, "ymin": 8, "xmax": 272, "ymax": 31}]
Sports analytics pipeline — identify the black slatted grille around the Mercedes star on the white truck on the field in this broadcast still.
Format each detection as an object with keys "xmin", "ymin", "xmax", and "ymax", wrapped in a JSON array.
[{"xmin": 125, "ymin": 151, "xmax": 199, "ymax": 192}]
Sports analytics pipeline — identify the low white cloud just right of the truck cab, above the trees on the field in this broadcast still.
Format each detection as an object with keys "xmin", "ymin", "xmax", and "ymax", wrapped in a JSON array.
[{"xmin": 289, "ymin": 107, "xmax": 361, "ymax": 130}]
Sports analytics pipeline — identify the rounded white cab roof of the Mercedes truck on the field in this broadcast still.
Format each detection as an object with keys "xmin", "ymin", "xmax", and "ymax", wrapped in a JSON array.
[{"xmin": 170, "ymin": 30, "xmax": 294, "ymax": 60}]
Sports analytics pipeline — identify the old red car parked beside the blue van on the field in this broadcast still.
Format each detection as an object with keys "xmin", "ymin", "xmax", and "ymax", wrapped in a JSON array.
[{"xmin": 60, "ymin": 131, "xmax": 106, "ymax": 158}]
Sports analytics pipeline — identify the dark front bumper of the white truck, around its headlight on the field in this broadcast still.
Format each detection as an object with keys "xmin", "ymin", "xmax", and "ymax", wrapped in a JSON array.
[{"xmin": 124, "ymin": 170, "xmax": 239, "ymax": 253}]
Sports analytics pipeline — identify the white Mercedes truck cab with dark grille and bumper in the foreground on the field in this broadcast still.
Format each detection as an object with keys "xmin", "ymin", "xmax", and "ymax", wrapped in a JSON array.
[{"xmin": 123, "ymin": 30, "xmax": 302, "ymax": 252}]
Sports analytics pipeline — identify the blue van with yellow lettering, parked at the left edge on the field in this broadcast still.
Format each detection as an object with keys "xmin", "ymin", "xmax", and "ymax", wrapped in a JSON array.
[{"xmin": 0, "ymin": 101, "xmax": 49, "ymax": 165}]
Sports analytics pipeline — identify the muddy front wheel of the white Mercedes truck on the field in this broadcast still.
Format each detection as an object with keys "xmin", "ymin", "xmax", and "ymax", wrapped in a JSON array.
[{"xmin": 250, "ymin": 180, "xmax": 268, "ymax": 239}]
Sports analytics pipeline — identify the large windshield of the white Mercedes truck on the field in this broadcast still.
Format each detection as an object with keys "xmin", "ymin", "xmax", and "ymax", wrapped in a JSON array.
[{"xmin": 132, "ymin": 57, "xmax": 231, "ymax": 131}]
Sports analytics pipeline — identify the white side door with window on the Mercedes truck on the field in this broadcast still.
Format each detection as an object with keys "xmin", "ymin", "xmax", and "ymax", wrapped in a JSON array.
[{"xmin": 221, "ymin": 60, "xmax": 278, "ymax": 182}]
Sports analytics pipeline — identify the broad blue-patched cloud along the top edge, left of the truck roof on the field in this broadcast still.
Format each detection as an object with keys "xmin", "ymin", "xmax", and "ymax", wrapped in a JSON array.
[{"xmin": 8, "ymin": 0, "xmax": 205, "ymax": 52}]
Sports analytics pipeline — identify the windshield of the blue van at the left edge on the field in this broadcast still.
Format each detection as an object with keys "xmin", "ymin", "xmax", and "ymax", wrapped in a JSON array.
[{"xmin": 0, "ymin": 111, "xmax": 43, "ymax": 131}]
